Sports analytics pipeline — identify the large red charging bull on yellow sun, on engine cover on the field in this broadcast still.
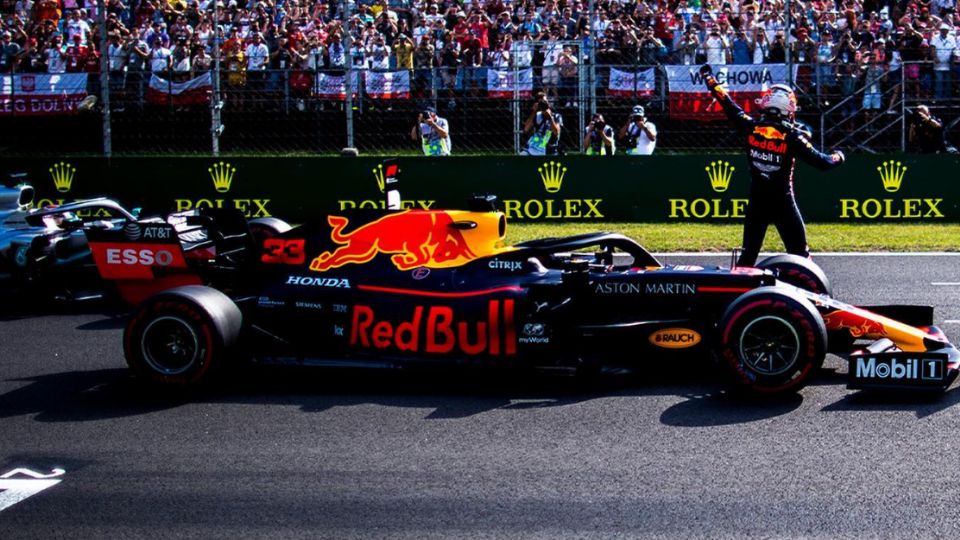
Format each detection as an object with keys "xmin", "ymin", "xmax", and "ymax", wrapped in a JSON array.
[{"xmin": 310, "ymin": 210, "xmax": 477, "ymax": 272}]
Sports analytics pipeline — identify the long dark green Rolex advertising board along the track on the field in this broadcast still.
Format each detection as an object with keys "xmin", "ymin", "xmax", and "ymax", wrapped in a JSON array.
[{"xmin": 0, "ymin": 154, "xmax": 960, "ymax": 223}]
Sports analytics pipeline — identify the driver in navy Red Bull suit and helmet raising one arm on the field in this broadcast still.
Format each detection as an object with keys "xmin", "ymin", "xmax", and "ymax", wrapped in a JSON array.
[{"xmin": 700, "ymin": 65, "xmax": 844, "ymax": 266}]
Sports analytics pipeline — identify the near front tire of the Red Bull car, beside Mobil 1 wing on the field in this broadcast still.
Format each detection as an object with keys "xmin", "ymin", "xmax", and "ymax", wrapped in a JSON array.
[{"xmin": 717, "ymin": 287, "xmax": 827, "ymax": 395}]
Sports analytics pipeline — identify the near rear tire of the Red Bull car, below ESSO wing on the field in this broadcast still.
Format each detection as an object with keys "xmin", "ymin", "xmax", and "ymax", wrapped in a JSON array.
[{"xmin": 123, "ymin": 285, "xmax": 243, "ymax": 388}]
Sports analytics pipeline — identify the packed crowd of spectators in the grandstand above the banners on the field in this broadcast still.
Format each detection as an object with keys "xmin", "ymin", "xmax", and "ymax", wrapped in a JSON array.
[{"xmin": 0, "ymin": 0, "xmax": 960, "ymax": 98}]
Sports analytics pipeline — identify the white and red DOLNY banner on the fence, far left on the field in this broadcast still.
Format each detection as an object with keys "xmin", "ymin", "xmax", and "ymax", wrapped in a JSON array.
[{"xmin": 0, "ymin": 73, "xmax": 87, "ymax": 115}]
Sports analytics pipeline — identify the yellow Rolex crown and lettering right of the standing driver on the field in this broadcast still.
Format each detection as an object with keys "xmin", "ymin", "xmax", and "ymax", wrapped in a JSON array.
[{"xmin": 840, "ymin": 159, "xmax": 944, "ymax": 219}]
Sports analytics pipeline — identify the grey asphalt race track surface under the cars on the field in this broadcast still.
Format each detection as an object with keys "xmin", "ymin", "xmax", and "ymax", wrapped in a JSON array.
[{"xmin": 0, "ymin": 256, "xmax": 960, "ymax": 539}]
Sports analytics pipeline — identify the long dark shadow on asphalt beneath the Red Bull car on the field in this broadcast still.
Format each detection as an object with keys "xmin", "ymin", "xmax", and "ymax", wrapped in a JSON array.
[{"xmin": 0, "ymin": 366, "xmax": 802, "ymax": 427}]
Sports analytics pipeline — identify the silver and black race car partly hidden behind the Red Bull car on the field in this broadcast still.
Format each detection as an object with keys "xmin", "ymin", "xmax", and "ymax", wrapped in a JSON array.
[{"xmin": 0, "ymin": 175, "xmax": 290, "ymax": 304}]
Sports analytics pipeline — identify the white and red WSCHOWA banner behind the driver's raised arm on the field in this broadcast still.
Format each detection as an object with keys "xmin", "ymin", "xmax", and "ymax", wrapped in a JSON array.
[{"xmin": 664, "ymin": 64, "xmax": 797, "ymax": 121}]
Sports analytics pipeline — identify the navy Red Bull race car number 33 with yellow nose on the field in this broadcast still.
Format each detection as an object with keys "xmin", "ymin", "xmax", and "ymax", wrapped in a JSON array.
[{"xmin": 101, "ymin": 167, "xmax": 960, "ymax": 394}]
